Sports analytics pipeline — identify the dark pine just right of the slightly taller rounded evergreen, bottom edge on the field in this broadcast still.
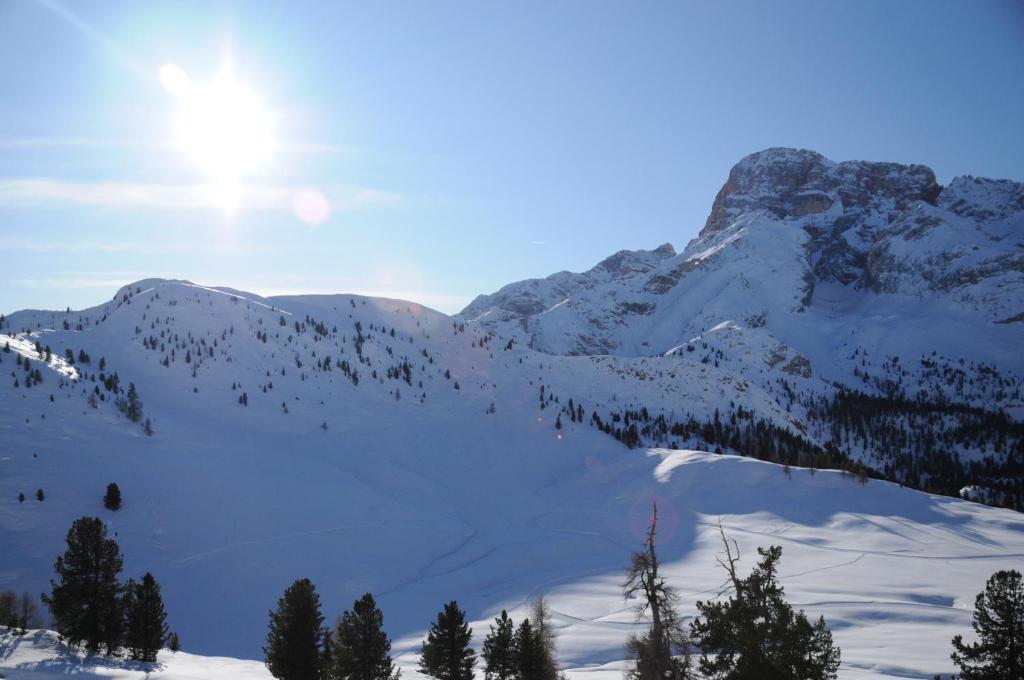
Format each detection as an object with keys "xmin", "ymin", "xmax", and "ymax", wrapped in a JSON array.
[{"xmin": 328, "ymin": 593, "xmax": 401, "ymax": 680}]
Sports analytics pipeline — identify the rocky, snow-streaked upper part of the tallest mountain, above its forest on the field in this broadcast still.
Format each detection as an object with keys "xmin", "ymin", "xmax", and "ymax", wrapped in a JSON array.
[{"xmin": 462, "ymin": 148, "xmax": 1024, "ymax": 364}]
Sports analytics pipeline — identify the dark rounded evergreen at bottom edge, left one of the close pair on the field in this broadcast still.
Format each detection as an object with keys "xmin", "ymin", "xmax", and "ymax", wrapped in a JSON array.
[{"xmin": 263, "ymin": 579, "xmax": 325, "ymax": 680}]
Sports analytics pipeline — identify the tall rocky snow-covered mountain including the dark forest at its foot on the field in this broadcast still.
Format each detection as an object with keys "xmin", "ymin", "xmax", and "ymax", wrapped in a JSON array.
[{"xmin": 459, "ymin": 148, "xmax": 1024, "ymax": 509}]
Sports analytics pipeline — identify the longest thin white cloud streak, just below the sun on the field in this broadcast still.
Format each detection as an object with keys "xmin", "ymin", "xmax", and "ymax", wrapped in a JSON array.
[{"xmin": 0, "ymin": 178, "xmax": 398, "ymax": 213}]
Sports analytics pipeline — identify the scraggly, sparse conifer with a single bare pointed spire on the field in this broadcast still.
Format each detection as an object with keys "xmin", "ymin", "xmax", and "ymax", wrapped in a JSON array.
[{"xmin": 623, "ymin": 504, "xmax": 690, "ymax": 680}]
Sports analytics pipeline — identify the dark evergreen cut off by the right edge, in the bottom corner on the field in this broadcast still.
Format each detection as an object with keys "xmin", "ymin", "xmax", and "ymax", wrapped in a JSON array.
[{"xmin": 952, "ymin": 570, "xmax": 1024, "ymax": 680}]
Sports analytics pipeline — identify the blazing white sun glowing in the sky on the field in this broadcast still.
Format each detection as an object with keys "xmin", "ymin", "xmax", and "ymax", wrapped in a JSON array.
[{"xmin": 159, "ymin": 63, "xmax": 275, "ymax": 210}]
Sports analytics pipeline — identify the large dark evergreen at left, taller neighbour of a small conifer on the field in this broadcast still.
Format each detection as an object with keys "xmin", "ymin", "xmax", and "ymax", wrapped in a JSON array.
[{"xmin": 42, "ymin": 517, "xmax": 123, "ymax": 654}]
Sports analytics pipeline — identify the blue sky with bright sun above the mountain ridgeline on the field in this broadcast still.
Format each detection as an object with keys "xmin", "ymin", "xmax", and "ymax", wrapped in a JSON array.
[{"xmin": 0, "ymin": 0, "xmax": 1024, "ymax": 312}]
